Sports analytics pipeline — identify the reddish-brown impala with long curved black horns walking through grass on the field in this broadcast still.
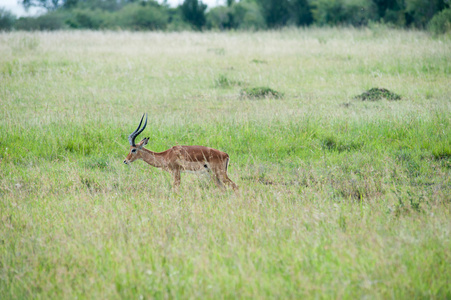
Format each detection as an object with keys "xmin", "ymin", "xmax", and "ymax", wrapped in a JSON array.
[{"xmin": 124, "ymin": 114, "xmax": 238, "ymax": 191}]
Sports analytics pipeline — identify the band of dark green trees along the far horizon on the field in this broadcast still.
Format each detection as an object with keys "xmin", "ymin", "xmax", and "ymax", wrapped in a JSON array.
[{"xmin": 0, "ymin": 0, "xmax": 451, "ymax": 33}]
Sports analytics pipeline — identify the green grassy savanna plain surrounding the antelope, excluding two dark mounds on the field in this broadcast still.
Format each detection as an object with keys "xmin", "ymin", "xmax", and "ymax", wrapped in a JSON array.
[{"xmin": 0, "ymin": 27, "xmax": 451, "ymax": 299}]
